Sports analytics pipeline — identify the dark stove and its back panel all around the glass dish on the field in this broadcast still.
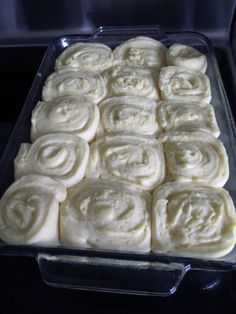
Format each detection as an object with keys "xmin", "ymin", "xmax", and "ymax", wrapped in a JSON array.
[{"xmin": 0, "ymin": 0, "xmax": 236, "ymax": 314}]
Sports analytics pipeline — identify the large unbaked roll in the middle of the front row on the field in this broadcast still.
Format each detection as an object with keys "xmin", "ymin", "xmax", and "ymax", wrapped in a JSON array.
[{"xmin": 60, "ymin": 179, "xmax": 151, "ymax": 252}]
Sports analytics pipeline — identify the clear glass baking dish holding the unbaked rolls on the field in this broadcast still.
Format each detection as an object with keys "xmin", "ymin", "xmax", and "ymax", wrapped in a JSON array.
[{"xmin": 0, "ymin": 26, "xmax": 236, "ymax": 296}]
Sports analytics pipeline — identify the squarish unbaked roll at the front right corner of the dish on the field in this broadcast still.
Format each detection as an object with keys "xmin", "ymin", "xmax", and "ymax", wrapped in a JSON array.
[{"xmin": 152, "ymin": 183, "xmax": 236, "ymax": 258}]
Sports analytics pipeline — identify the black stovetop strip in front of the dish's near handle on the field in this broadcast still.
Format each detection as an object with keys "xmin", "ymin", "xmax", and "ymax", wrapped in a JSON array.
[{"xmin": 0, "ymin": 256, "xmax": 236, "ymax": 314}]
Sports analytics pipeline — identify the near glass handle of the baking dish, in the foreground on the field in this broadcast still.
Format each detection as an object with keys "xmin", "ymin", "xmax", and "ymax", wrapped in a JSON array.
[{"xmin": 37, "ymin": 254, "xmax": 189, "ymax": 296}]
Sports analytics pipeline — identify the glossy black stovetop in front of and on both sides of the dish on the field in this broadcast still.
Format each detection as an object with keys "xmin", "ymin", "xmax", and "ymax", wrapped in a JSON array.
[{"xmin": 0, "ymin": 42, "xmax": 236, "ymax": 314}]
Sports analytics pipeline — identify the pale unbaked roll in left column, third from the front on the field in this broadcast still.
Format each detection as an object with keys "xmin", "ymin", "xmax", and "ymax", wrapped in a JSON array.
[{"xmin": 31, "ymin": 96, "xmax": 100, "ymax": 142}]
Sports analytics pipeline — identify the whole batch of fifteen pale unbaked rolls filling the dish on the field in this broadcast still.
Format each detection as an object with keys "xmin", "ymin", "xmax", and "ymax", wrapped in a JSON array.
[{"xmin": 0, "ymin": 37, "xmax": 236, "ymax": 258}]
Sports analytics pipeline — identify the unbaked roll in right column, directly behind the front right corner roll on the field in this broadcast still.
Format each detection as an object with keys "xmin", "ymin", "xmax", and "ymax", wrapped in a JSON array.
[{"xmin": 159, "ymin": 131, "xmax": 229, "ymax": 187}]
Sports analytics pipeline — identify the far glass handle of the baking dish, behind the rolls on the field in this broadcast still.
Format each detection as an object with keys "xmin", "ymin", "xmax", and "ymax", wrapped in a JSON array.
[{"xmin": 93, "ymin": 25, "xmax": 167, "ymax": 39}]
